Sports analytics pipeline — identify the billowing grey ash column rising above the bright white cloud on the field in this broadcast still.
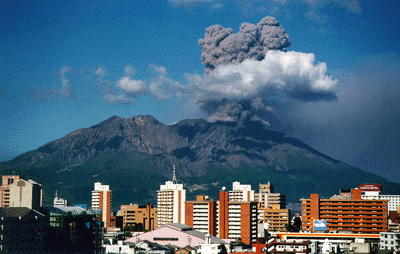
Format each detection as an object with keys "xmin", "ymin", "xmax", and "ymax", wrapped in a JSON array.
[{"xmin": 199, "ymin": 16, "xmax": 290, "ymax": 73}]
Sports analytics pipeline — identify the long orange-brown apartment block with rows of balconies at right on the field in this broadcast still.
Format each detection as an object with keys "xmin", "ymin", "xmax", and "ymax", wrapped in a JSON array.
[{"xmin": 300, "ymin": 189, "xmax": 388, "ymax": 234}]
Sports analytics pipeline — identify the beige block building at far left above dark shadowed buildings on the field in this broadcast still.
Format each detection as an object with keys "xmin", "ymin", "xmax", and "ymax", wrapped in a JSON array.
[{"xmin": 9, "ymin": 179, "xmax": 42, "ymax": 211}]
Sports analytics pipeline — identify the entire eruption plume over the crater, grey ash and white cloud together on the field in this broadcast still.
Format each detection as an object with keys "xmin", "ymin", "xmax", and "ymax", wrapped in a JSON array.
[{"xmin": 195, "ymin": 16, "xmax": 337, "ymax": 122}]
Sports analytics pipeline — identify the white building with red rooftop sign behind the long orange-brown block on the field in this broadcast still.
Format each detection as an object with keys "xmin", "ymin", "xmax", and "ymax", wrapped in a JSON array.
[{"xmin": 358, "ymin": 183, "xmax": 400, "ymax": 211}]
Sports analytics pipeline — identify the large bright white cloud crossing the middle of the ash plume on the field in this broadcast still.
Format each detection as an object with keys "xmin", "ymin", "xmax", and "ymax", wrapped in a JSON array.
[{"xmin": 188, "ymin": 50, "xmax": 337, "ymax": 100}]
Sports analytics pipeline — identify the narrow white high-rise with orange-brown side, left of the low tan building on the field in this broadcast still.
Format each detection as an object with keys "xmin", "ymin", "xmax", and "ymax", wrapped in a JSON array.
[{"xmin": 92, "ymin": 182, "xmax": 111, "ymax": 227}]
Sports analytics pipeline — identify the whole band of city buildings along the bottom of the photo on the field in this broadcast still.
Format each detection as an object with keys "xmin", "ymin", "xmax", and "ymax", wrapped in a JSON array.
[{"xmin": 0, "ymin": 171, "xmax": 400, "ymax": 254}]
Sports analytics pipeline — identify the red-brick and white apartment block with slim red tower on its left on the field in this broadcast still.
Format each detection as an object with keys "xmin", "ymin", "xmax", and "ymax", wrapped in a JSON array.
[{"xmin": 218, "ymin": 187, "xmax": 257, "ymax": 244}]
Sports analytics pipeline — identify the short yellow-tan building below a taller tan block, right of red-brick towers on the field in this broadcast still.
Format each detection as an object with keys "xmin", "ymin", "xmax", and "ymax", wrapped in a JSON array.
[{"xmin": 259, "ymin": 204, "xmax": 290, "ymax": 232}]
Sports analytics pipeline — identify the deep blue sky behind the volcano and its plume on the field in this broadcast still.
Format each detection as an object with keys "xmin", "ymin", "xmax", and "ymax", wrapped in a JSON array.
[{"xmin": 0, "ymin": 0, "xmax": 400, "ymax": 181}]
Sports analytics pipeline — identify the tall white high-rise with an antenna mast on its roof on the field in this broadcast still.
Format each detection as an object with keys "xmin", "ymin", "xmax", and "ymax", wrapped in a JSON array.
[{"xmin": 157, "ymin": 181, "xmax": 186, "ymax": 227}]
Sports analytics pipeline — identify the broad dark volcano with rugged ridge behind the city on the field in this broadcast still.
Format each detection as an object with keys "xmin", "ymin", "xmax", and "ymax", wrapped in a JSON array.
[{"xmin": 0, "ymin": 115, "xmax": 400, "ymax": 206}]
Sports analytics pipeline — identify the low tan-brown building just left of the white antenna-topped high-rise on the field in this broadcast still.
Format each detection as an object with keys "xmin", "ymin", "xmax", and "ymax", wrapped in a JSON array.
[{"xmin": 120, "ymin": 204, "xmax": 157, "ymax": 231}]
